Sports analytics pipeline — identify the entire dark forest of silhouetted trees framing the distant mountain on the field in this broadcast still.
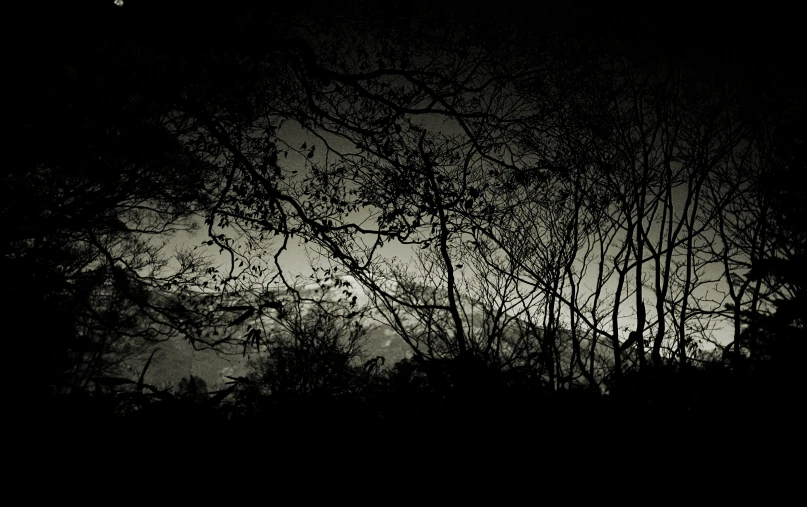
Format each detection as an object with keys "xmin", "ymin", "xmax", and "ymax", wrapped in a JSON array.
[{"xmin": 9, "ymin": 0, "xmax": 807, "ymax": 452}]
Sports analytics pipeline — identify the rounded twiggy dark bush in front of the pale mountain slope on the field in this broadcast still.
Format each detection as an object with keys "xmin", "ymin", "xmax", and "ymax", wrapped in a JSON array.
[{"xmin": 227, "ymin": 279, "xmax": 370, "ymax": 422}]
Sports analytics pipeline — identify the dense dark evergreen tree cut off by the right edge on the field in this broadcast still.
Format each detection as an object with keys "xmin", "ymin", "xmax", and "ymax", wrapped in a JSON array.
[{"xmin": 733, "ymin": 105, "xmax": 807, "ymax": 401}]
